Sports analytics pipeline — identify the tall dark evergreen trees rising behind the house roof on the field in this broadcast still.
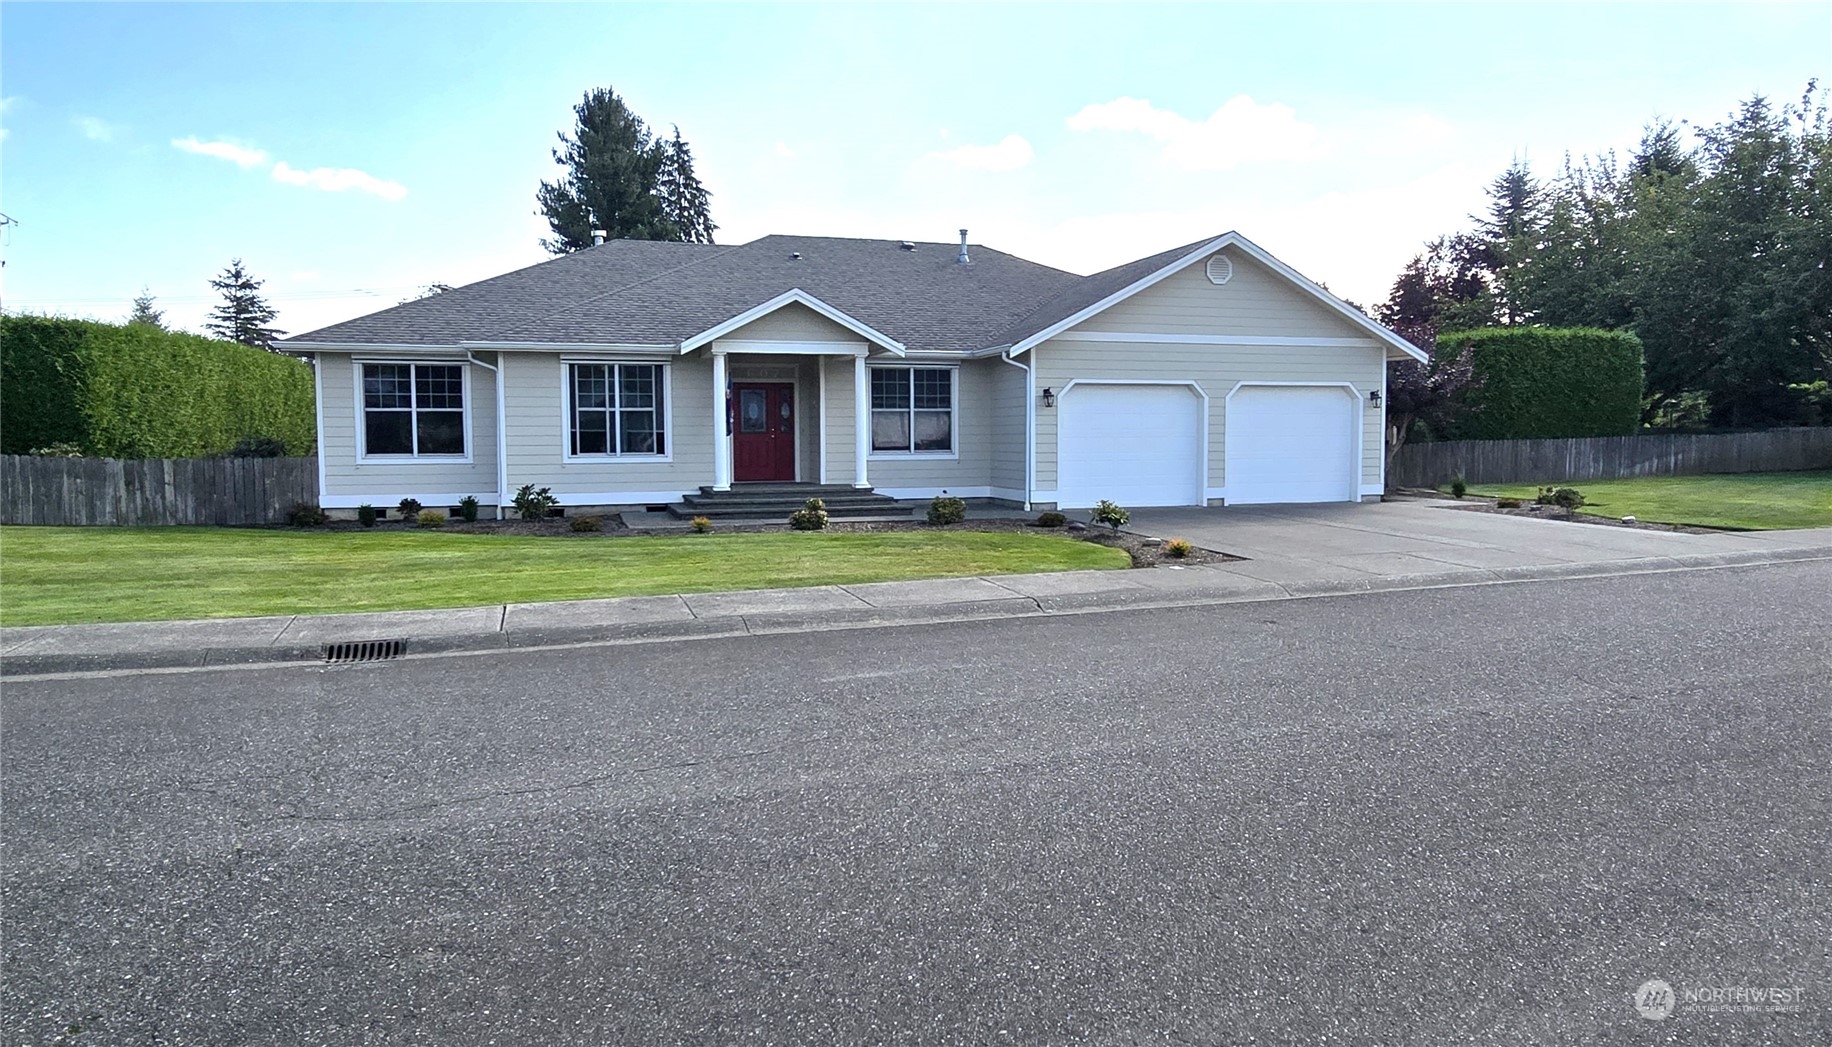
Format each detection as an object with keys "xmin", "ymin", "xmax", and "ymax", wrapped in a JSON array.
[{"xmin": 535, "ymin": 88, "xmax": 716, "ymax": 254}]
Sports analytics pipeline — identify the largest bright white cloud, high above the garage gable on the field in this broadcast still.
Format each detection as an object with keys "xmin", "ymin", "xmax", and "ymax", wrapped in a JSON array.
[{"xmin": 1068, "ymin": 95, "xmax": 1323, "ymax": 170}]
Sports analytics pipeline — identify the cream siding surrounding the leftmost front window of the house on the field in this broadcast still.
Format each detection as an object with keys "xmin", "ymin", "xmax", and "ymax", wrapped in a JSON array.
[{"xmin": 317, "ymin": 353, "xmax": 496, "ymax": 509}]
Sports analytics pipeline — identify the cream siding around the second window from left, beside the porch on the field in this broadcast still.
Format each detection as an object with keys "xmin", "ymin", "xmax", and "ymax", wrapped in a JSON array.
[{"xmin": 504, "ymin": 353, "xmax": 716, "ymax": 503}]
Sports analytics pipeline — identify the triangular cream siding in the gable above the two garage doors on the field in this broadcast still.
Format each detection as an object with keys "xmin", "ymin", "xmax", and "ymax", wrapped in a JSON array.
[{"xmin": 1075, "ymin": 249, "xmax": 1369, "ymax": 339}]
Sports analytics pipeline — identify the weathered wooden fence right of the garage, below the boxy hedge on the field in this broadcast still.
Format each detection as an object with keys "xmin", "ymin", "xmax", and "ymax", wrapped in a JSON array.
[{"xmin": 1387, "ymin": 426, "xmax": 1832, "ymax": 487}]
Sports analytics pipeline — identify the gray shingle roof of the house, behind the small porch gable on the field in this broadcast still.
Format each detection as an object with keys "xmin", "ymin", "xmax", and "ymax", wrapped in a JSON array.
[{"xmin": 280, "ymin": 236, "xmax": 1204, "ymax": 351}]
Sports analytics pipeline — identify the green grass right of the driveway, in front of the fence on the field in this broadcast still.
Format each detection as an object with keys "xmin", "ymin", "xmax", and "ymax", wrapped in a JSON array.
[{"xmin": 1469, "ymin": 470, "xmax": 1832, "ymax": 531}]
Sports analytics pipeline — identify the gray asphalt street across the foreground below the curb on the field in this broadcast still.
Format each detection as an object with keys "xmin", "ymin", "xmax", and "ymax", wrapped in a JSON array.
[{"xmin": 0, "ymin": 562, "xmax": 1832, "ymax": 1045}]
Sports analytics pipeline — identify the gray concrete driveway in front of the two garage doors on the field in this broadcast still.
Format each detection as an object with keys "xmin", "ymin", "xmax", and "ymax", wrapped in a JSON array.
[{"xmin": 1129, "ymin": 498, "xmax": 1832, "ymax": 582}]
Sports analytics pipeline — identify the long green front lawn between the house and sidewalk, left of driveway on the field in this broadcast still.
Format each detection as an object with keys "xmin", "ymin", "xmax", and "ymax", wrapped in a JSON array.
[{"xmin": 0, "ymin": 527, "xmax": 1130, "ymax": 626}]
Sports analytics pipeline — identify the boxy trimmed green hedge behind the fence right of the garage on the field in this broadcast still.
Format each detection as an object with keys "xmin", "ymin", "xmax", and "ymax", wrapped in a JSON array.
[{"xmin": 1438, "ymin": 328, "xmax": 1641, "ymax": 439}]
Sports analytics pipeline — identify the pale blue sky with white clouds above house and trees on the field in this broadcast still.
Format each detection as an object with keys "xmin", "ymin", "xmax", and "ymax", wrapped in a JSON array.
[{"xmin": 0, "ymin": 4, "xmax": 1832, "ymax": 333}]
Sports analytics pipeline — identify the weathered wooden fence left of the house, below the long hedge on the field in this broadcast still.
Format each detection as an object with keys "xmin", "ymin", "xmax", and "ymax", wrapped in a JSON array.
[{"xmin": 0, "ymin": 454, "xmax": 319, "ymax": 527}]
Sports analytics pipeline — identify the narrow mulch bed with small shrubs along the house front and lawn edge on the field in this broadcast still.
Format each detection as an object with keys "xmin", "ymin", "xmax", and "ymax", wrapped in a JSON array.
[{"xmin": 307, "ymin": 513, "xmax": 1240, "ymax": 567}]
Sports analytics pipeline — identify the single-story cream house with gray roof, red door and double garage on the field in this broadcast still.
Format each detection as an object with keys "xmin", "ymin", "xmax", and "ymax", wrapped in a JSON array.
[{"xmin": 280, "ymin": 231, "xmax": 1423, "ymax": 511}]
